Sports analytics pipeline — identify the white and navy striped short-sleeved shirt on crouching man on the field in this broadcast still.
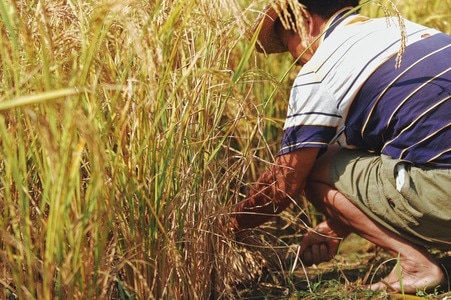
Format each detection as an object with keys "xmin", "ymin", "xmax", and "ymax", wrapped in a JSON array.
[{"xmin": 279, "ymin": 15, "xmax": 451, "ymax": 168}]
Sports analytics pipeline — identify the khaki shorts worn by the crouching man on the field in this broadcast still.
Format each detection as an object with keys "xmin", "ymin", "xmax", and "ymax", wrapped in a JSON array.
[{"xmin": 330, "ymin": 149, "xmax": 451, "ymax": 249}]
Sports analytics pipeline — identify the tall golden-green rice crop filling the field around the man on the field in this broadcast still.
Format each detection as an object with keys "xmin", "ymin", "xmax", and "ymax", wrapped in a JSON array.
[{"xmin": 0, "ymin": 0, "xmax": 451, "ymax": 300}]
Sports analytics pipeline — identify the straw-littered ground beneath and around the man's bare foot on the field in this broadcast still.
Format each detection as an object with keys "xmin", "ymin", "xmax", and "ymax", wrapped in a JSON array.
[{"xmin": 231, "ymin": 229, "xmax": 451, "ymax": 300}]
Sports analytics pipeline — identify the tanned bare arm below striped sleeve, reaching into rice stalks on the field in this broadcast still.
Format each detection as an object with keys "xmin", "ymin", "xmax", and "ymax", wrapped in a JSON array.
[{"xmin": 231, "ymin": 148, "xmax": 320, "ymax": 230}]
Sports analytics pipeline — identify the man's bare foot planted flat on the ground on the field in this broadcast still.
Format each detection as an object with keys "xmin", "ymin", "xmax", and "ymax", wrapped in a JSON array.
[{"xmin": 368, "ymin": 257, "xmax": 445, "ymax": 294}]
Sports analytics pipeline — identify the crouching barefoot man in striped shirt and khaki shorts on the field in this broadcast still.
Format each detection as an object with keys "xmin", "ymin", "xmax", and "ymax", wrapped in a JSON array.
[{"xmin": 231, "ymin": 0, "xmax": 451, "ymax": 293}]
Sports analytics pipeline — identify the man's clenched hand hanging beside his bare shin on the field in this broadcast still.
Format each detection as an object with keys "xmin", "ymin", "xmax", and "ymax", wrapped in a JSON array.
[{"xmin": 299, "ymin": 220, "xmax": 347, "ymax": 266}]
